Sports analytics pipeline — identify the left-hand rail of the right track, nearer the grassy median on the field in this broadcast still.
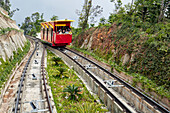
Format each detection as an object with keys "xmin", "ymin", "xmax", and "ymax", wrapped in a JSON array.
[{"xmin": 54, "ymin": 50, "xmax": 131, "ymax": 113}]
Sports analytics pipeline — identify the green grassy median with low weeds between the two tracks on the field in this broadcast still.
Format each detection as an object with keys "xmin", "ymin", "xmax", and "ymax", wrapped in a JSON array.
[{"xmin": 47, "ymin": 51, "xmax": 106, "ymax": 113}]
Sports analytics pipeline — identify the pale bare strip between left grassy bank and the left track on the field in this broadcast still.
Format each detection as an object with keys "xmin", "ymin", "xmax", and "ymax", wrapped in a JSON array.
[{"xmin": 0, "ymin": 37, "xmax": 34, "ymax": 113}]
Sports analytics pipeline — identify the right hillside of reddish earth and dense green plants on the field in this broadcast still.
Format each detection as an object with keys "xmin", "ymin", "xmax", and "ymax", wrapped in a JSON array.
[{"xmin": 73, "ymin": 22, "xmax": 170, "ymax": 106}]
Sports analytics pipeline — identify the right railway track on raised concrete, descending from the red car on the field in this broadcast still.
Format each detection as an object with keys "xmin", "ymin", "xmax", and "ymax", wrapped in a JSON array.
[{"xmin": 48, "ymin": 47, "xmax": 169, "ymax": 113}]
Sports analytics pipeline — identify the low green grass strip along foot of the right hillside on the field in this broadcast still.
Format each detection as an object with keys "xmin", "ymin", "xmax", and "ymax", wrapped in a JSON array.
[{"xmin": 69, "ymin": 46, "xmax": 170, "ymax": 99}]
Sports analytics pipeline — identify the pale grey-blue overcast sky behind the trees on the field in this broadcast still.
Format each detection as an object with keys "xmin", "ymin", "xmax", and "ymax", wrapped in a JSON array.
[{"xmin": 10, "ymin": 0, "xmax": 131, "ymax": 27}]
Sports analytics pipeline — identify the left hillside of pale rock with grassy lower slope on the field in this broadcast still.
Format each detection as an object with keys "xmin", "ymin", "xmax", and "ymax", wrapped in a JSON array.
[{"xmin": 0, "ymin": 8, "xmax": 30, "ymax": 94}]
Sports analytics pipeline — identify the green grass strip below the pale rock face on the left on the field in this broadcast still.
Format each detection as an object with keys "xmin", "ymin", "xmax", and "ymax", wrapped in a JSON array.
[{"xmin": 0, "ymin": 41, "xmax": 30, "ymax": 87}]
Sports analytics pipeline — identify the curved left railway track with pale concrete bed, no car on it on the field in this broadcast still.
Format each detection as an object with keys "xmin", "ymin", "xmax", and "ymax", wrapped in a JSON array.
[{"xmin": 13, "ymin": 36, "xmax": 56, "ymax": 113}]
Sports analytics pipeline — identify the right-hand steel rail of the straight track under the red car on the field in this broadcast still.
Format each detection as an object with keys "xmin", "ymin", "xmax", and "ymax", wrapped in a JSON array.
[{"xmin": 65, "ymin": 48, "xmax": 170, "ymax": 113}]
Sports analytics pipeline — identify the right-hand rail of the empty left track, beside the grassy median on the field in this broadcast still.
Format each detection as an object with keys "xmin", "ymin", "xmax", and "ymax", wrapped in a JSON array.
[{"xmin": 41, "ymin": 47, "xmax": 53, "ymax": 113}]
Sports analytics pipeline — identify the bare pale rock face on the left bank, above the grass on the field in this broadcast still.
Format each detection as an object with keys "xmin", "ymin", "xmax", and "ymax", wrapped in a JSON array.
[{"xmin": 0, "ymin": 8, "xmax": 26, "ymax": 64}]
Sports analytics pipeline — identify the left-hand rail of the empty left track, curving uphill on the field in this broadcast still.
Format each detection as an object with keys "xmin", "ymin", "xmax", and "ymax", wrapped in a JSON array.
[{"xmin": 14, "ymin": 39, "xmax": 37, "ymax": 113}]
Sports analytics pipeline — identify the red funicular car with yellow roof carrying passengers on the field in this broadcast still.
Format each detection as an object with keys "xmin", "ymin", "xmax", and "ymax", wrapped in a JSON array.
[{"xmin": 41, "ymin": 19, "xmax": 74, "ymax": 47}]
